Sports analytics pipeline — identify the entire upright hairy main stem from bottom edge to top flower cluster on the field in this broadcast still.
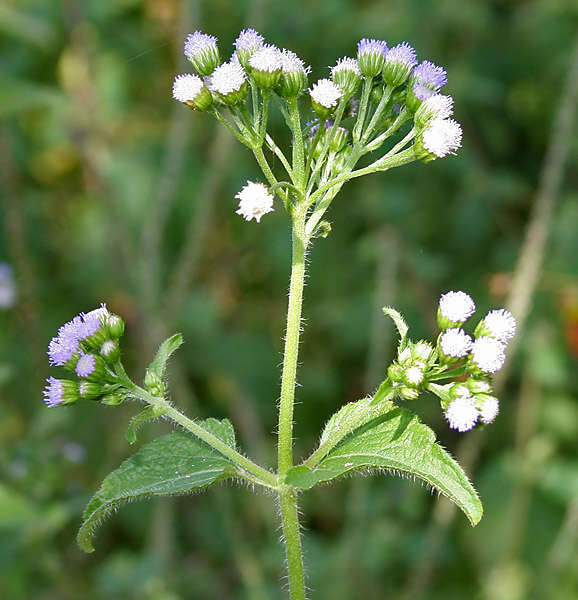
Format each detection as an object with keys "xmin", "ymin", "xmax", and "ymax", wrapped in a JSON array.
[{"xmin": 278, "ymin": 203, "xmax": 307, "ymax": 600}]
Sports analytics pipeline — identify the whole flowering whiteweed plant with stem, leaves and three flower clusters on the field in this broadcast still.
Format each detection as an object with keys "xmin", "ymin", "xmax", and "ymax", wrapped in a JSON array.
[{"xmin": 44, "ymin": 29, "xmax": 516, "ymax": 600}]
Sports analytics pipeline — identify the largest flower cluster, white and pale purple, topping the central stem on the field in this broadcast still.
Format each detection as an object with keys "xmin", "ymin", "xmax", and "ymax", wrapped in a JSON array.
[{"xmin": 173, "ymin": 29, "xmax": 462, "ymax": 222}]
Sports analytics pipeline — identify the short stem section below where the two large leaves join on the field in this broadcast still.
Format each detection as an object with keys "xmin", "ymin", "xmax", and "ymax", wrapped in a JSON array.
[{"xmin": 279, "ymin": 489, "xmax": 305, "ymax": 600}]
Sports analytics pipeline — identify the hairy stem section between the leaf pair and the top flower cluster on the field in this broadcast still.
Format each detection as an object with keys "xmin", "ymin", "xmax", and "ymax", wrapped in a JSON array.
[{"xmin": 278, "ymin": 209, "xmax": 307, "ymax": 477}]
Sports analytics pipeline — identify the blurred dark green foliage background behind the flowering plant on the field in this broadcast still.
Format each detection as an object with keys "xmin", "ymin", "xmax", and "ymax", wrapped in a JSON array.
[{"xmin": 0, "ymin": 0, "xmax": 578, "ymax": 600}]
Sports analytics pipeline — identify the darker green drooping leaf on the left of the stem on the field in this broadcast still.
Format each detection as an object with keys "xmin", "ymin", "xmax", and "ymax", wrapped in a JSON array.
[{"xmin": 77, "ymin": 419, "xmax": 238, "ymax": 552}]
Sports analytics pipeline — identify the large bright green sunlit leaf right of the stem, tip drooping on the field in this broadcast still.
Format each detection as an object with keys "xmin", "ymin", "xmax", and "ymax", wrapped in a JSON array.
[{"xmin": 285, "ymin": 403, "xmax": 483, "ymax": 525}]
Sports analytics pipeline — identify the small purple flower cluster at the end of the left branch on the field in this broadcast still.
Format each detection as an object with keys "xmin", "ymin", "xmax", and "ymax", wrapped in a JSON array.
[{"xmin": 44, "ymin": 304, "xmax": 124, "ymax": 408}]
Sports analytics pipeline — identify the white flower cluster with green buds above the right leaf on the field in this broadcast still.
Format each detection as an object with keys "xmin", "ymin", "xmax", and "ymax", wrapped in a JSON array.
[{"xmin": 388, "ymin": 291, "xmax": 516, "ymax": 432}]
